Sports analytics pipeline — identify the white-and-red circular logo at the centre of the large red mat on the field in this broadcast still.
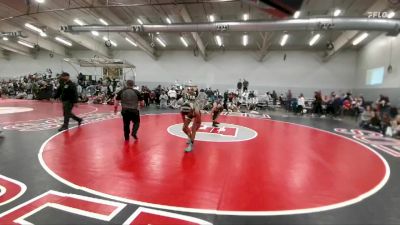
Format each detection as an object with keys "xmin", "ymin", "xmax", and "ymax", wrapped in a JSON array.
[{"xmin": 167, "ymin": 122, "xmax": 257, "ymax": 142}]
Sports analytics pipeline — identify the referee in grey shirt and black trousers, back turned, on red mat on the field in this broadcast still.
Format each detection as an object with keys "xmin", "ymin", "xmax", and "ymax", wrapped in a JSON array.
[{"xmin": 114, "ymin": 80, "xmax": 143, "ymax": 141}]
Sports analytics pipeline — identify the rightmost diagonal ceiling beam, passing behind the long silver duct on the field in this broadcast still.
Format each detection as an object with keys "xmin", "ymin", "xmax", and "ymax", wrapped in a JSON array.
[{"xmin": 322, "ymin": 0, "xmax": 389, "ymax": 62}]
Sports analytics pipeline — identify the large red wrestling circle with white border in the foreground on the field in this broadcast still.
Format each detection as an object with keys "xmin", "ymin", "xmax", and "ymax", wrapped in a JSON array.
[{"xmin": 39, "ymin": 114, "xmax": 389, "ymax": 215}]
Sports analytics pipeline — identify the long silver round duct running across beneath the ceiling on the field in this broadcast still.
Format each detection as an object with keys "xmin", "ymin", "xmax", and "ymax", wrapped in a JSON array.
[{"xmin": 62, "ymin": 17, "xmax": 400, "ymax": 33}]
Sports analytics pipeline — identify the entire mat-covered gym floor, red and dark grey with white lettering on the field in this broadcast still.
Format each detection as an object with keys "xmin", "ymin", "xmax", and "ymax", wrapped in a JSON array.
[{"xmin": 0, "ymin": 100, "xmax": 400, "ymax": 225}]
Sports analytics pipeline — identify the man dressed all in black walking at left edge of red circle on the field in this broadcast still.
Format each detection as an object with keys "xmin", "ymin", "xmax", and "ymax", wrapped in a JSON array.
[{"xmin": 54, "ymin": 72, "xmax": 82, "ymax": 131}]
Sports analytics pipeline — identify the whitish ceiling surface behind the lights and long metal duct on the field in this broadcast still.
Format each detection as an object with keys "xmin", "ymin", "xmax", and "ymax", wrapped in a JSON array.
[{"xmin": 0, "ymin": 0, "xmax": 398, "ymax": 59}]
